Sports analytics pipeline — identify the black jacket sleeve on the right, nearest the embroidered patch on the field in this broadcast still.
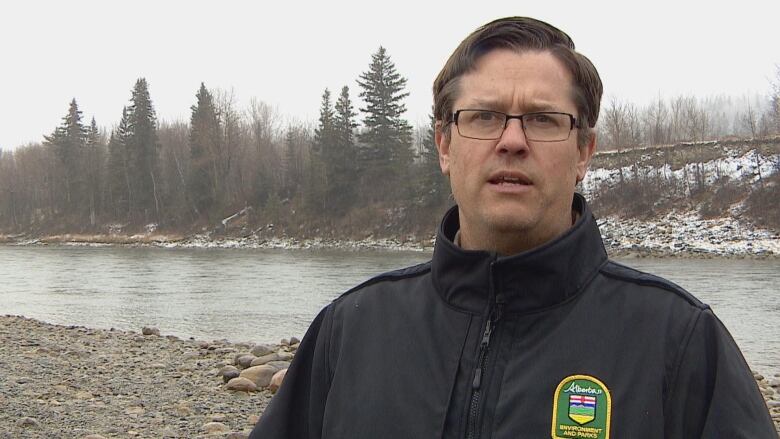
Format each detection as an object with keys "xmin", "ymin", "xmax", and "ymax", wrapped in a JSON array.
[{"xmin": 664, "ymin": 309, "xmax": 778, "ymax": 439}]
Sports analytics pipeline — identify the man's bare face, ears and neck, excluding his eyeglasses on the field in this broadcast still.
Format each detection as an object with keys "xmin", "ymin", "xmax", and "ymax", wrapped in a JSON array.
[{"xmin": 436, "ymin": 49, "xmax": 595, "ymax": 251}]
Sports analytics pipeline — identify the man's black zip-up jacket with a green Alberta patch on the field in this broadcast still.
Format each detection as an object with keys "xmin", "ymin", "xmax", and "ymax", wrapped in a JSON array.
[{"xmin": 250, "ymin": 195, "xmax": 777, "ymax": 439}]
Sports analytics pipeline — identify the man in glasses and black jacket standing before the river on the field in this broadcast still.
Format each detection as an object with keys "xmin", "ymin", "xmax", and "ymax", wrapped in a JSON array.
[{"xmin": 251, "ymin": 17, "xmax": 776, "ymax": 439}]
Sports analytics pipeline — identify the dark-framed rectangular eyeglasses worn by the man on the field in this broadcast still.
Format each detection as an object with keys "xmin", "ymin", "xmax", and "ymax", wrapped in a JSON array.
[{"xmin": 449, "ymin": 109, "xmax": 580, "ymax": 142}]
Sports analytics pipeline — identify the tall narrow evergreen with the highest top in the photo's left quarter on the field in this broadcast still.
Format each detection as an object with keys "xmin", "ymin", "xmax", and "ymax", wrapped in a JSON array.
[{"xmin": 126, "ymin": 78, "xmax": 161, "ymax": 222}]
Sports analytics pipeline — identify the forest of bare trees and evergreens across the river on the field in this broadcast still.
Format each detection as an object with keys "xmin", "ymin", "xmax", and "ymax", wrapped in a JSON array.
[{"xmin": 0, "ymin": 47, "xmax": 780, "ymax": 238}]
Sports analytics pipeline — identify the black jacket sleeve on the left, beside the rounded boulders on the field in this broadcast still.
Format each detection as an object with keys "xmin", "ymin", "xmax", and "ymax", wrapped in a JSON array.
[{"xmin": 249, "ymin": 304, "xmax": 333, "ymax": 439}]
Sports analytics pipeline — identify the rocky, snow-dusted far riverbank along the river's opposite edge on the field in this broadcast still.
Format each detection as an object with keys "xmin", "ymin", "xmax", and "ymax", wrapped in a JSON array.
[{"xmin": 0, "ymin": 212, "xmax": 780, "ymax": 259}]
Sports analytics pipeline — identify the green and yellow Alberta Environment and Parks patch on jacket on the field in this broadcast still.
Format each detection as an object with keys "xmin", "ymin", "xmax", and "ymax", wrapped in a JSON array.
[{"xmin": 552, "ymin": 375, "xmax": 612, "ymax": 439}]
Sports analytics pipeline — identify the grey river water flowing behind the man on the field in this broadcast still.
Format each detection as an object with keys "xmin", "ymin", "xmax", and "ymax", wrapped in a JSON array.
[{"xmin": 0, "ymin": 246, "xmax": 780, "ymax": 373}]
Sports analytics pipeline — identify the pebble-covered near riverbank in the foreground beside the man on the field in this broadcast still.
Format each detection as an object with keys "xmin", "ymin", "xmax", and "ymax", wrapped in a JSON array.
[{"xmin": 0, "ymin": 316, "xmax": 780, "ymax": 439}]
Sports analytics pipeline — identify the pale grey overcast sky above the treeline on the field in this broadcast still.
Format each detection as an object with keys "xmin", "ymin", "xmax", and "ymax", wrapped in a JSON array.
[{"xmin": 0, "ymin": 0, "xmax": 780, "ymax": 148}]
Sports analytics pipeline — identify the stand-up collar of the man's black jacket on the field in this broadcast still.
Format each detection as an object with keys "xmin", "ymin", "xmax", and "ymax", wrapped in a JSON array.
[{"xmin": 431, "ymin": 194, "xmax": 607, "ymax": 313}]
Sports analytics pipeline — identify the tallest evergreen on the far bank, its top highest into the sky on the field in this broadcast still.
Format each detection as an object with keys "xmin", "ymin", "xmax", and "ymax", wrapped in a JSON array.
[{"xmin": 358, "ymin": 46, "xmax": 412, "ymax": 198}]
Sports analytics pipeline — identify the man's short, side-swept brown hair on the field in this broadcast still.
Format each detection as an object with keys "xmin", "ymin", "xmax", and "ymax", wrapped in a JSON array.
[{"xmin": 433, "ymin": 17, "xmax": 603, "ymax": 146}]
